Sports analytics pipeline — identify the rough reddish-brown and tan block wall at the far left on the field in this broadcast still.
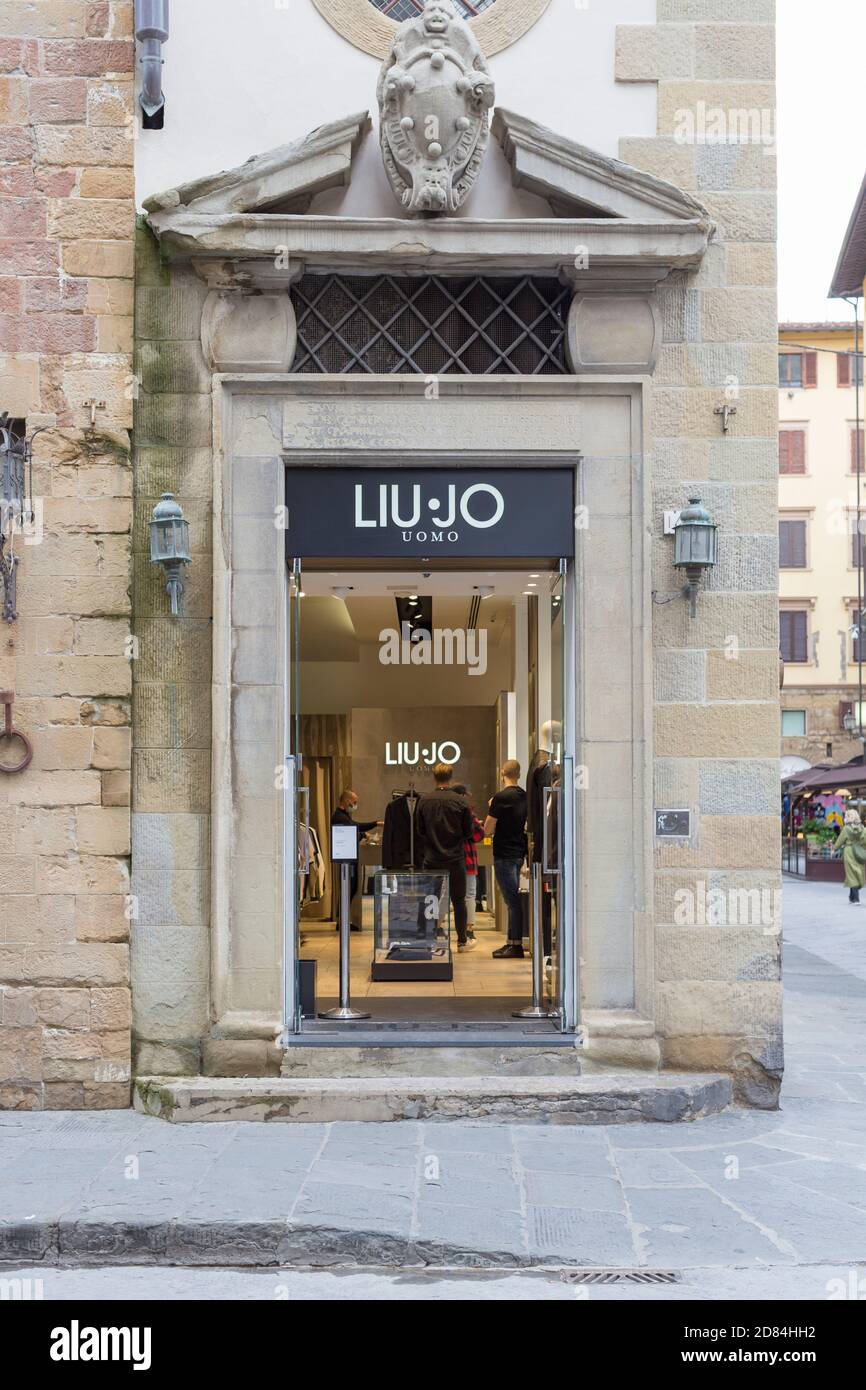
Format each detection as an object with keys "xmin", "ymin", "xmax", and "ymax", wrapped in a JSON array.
[{"xmin": 0, "ymin": 0, "xmax": 135, "ymax": 1109}]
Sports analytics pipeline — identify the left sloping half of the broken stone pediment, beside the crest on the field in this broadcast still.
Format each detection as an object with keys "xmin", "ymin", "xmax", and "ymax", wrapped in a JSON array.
[{"xmin": 145, "ymin": 111, "xmax": 371, "ymax": 215}]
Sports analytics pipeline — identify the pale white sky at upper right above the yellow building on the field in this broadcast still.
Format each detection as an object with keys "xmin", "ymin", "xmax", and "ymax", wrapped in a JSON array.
[{"xmin": 777, "ymin": 0, "xmax": 866, "ymax": 322}]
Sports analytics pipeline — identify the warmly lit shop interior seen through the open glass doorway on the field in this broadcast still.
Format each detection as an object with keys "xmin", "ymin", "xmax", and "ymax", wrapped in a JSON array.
[{"xmin": 292, "ymin": 564, "xmax": 563, "ymax": 1031}]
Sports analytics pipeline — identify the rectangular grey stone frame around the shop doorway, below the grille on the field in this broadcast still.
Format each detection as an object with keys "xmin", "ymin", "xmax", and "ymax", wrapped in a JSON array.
[{"xmin": 211, "ymin": 373, "xmax": 657, "ymax": 1054}]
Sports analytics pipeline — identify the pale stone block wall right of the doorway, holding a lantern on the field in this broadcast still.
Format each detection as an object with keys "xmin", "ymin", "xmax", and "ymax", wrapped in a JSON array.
[{"xmin": 616, "ymin": 0, "xmax": 783, "ymax": 1105}]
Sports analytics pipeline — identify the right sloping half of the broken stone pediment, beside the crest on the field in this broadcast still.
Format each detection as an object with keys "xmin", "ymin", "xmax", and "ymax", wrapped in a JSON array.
[{"xmin": 492, "ymin": 107, "xmax": 708, "ymax": 222}]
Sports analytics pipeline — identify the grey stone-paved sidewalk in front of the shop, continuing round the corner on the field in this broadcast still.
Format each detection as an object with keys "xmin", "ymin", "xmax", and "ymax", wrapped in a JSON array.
[{"xmin": 0, "ymin": 881, "xmax": 866, "ymax": 1278}]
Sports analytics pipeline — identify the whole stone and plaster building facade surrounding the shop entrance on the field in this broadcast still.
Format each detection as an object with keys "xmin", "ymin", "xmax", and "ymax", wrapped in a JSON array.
[{"xmin": 0, "ymin": 0, "xmax": 783, "ymax": 1106}]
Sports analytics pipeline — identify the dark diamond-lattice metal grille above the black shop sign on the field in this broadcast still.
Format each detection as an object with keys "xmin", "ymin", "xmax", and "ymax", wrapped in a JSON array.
[{"xmin": 292, "ymin": 275, "xmax": 571, "ymax": 377}]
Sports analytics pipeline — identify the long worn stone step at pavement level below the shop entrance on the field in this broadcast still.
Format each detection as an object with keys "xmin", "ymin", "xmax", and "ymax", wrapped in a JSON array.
[{"xmin": 133, "ymin": 1072, "xmax": 731, "ymax": 1125}]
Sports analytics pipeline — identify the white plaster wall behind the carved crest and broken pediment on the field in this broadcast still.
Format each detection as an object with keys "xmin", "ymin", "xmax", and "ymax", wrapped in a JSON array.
[{"xmin": 136, "ymin": 0, "xmax": 656, "ymax": 208}]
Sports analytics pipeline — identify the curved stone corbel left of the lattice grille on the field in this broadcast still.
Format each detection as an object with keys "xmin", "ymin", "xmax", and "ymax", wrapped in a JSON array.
[{"xmin": 202, "ymin": 286, "xmax": 297, "ymax": 373}]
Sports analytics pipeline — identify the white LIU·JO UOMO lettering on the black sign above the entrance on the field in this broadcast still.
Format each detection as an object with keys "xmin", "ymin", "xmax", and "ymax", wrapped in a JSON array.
[{"xmin": 354, "ymin": 482, "xmax": 505, "ymax": 545}]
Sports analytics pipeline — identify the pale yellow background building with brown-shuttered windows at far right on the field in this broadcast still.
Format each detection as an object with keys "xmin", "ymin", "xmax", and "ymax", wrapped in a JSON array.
[{"xmin": 778, "ymin": 322, "xmax": 866, "ymax": 765}]
